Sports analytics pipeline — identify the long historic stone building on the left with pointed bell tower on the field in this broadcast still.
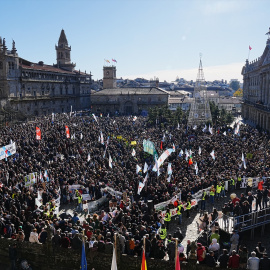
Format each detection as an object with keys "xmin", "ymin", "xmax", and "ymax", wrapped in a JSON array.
[{"xmin": 0, "ymin": 30, "xmax": 91, "ymax": 116}]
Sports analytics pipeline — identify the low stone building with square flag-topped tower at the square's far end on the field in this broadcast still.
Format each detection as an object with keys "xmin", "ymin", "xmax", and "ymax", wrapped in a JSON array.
[{"xmin": 91, "ymin": 66, "xmax": 169, "ymax": 115}]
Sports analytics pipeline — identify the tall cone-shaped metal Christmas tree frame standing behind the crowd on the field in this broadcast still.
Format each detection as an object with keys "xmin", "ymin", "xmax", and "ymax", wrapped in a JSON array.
[{"xmin": 188, "ymin": 59, "xmax": 212, "ymax": 127}]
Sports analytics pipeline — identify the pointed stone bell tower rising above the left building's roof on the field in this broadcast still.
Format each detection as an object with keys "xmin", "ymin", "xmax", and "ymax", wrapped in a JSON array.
[{"xmin": 55, "ymin": 29, "xmax": 76, "ymax": 71}]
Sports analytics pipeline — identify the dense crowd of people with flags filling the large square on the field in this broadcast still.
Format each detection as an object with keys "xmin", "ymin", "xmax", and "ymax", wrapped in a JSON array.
[{"xmin": 0, "ymin": 114, "xmax": 270, "ymax": 268}]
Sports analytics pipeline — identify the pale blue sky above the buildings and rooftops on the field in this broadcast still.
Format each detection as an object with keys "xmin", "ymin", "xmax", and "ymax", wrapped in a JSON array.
[{"xmin": 0, "ymin": 0, "xmax": 270, "ymax": 81}]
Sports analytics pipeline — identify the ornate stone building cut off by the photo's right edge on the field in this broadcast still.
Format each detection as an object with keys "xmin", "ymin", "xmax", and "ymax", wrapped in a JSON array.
[{"xmin": 242, "ymin": 28, "xmax": 270, "ymax": 130}]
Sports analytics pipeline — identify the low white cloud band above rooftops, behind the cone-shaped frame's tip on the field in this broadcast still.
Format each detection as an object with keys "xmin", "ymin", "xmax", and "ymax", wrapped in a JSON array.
[{"xmin": 123, "ymin": 62, "xmax": 244, "ymax": 81}]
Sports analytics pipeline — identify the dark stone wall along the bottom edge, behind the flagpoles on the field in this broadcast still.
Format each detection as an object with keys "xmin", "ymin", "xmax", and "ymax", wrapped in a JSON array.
[{"xmin": 0, "ymin": 238, "xmax": 226, "ymax": 270}]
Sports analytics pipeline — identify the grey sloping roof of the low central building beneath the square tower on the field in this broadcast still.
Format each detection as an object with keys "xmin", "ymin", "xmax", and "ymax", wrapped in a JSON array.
[{"xmin": 93, "ymin": 87, "xmax": 168, "ymax": 96}]
